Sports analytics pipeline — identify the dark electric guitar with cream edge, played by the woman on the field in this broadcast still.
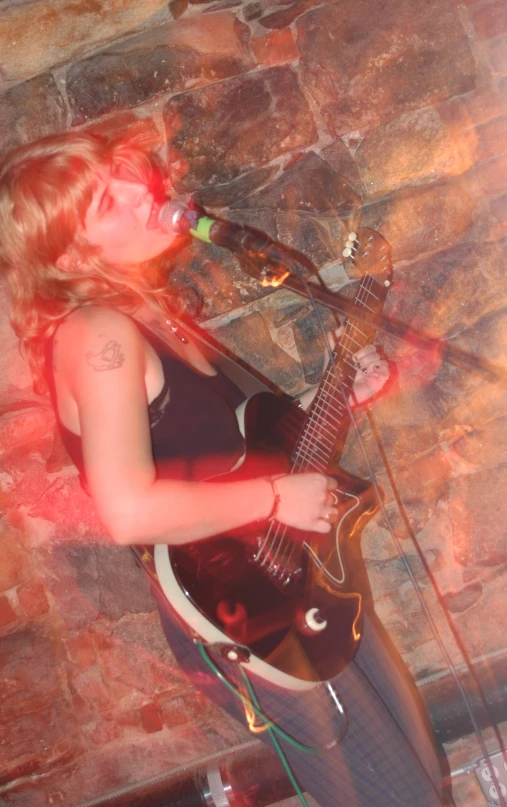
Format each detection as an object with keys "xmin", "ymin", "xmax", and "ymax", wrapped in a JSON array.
[{"xmin": 141, "ymin": 228, "xmax": 392, "ymax": 690}]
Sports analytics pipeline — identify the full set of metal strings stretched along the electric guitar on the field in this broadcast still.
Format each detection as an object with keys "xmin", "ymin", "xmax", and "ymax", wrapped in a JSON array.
[{"xmin": 257, "ymin": 275, "xmax": 380, "ymax": 571}]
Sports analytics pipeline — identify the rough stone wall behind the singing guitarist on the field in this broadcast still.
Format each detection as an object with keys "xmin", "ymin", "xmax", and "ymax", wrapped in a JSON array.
[{"xmin": 0, "ymin": 0, "xmax": 507, "ymax": 807}]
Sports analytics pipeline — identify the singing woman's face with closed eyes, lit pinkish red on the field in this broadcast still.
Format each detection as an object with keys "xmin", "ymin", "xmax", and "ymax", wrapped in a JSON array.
[{"xmin": 84, "ymin": 167, "xmax": 178, "ymax": 265}]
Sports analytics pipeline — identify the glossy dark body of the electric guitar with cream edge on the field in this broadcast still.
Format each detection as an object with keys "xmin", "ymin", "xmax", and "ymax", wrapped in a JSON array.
[{"xmin": 155, "ymin": 393, "xmax": 376, "ymax": 688}]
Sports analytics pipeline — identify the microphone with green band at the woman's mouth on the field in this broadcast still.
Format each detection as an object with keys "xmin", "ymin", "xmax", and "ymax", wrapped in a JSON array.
[{"xmin": 158, "ymin": 199, "xmax": 302, "ymax": 286}]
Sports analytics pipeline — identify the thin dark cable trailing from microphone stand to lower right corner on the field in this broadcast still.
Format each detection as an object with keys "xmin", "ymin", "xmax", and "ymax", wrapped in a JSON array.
[{"xmin": 303, "ymin": 278, "xmax": 507, "ymax": 807}]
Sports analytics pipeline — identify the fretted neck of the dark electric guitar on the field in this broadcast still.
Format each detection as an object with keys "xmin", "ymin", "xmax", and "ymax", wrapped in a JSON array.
[{"xmin": 292, "ymin": 235, "xmax": 389, "ymax": 473}]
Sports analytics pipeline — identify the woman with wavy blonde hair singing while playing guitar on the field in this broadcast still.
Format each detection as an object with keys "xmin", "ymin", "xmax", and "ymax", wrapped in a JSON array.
[{"xmin": 0, "ymin": 133, "xmax": 440, "ymax": 807}]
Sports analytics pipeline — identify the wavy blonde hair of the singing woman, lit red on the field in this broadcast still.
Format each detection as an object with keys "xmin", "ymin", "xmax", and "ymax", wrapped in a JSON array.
[{"xmin": 0, "ymin": 132, "xmax": 181, "ymax": 392}]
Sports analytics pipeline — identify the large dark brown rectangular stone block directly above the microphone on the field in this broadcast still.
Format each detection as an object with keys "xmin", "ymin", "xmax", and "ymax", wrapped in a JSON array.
[{"xmin": 164, "ymin": 67, "xmax": 317, "ymax": 190}]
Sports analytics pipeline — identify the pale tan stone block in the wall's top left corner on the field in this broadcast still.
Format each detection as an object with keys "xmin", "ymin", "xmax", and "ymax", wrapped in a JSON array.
[{"xmin": 0, "ymin": 0, "xmax": 168, "ymax": 81}]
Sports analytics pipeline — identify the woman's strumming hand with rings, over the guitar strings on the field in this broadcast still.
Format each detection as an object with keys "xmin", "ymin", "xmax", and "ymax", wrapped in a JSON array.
[{"xmin": 272, "ymin": 473, "xmax": 338, "ymax": 533}]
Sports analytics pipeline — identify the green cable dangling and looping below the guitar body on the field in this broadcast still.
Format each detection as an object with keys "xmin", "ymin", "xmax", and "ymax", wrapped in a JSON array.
[{"xmin": 195, "ymin": 640, "xmax": 348, "ymax": 807}]
